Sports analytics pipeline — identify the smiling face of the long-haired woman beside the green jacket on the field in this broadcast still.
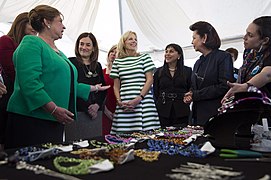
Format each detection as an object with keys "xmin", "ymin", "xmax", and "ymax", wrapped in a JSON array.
[{"xmin": 78, "ymin": 37, "xmax": 94, "ymax": 59}]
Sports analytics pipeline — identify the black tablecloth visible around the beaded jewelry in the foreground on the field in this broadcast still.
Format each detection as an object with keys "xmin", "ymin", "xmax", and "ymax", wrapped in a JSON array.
[{"xmin": 0, "ymin": 138, "xmax": 271, "ymax": 180}]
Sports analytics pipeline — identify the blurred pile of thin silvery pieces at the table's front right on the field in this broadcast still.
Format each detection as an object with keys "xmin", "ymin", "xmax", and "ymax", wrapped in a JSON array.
[{"xmin": 166, "ymin": 162, "xmax": 245, "ymax": 180}]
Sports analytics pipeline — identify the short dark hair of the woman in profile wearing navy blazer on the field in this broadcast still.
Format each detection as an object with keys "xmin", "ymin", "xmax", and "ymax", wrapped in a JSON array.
[{"xmin": 189, "ymin": 21, "xmax": 221, "ymax": 49}]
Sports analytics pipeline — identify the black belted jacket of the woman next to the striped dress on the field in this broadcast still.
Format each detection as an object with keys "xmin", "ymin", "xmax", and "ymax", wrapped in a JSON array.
[{"xmin": 153, "ymin": 64, "xmax": 192, "ymax": 118}]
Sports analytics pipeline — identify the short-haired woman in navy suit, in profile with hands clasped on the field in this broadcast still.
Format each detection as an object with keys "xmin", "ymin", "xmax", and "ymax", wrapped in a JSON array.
[{"xmin": 184, "ymin": 21, "xmax": 234, "ymax": 125}]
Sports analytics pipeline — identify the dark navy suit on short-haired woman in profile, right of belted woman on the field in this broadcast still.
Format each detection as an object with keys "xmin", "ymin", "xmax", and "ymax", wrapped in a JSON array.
[{"xmin": 191, "ymin": 50, "xmax": 234, "ymax": 125}]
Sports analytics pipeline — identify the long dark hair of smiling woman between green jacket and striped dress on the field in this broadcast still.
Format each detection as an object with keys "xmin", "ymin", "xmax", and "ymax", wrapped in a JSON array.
[{"xmin": 75, "ymin": 32, "xmax": 99, "ymax": 71}]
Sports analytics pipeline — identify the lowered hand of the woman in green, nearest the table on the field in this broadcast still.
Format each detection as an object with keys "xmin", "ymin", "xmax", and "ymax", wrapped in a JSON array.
[{"xmin": 52, "ymin": 107, "xmax": 74, "ymax": 124}]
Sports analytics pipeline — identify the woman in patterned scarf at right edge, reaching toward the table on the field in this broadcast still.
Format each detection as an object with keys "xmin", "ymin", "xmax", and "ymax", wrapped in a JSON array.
[{"xmin": 222, "ymin": 16, "xmax": 271, "ymax": 102}]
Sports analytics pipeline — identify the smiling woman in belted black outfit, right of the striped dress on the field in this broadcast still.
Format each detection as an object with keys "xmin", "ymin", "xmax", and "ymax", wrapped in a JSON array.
[{"xmin": 153, "ymin": 44, "xmax": 192, "ymax": 127}]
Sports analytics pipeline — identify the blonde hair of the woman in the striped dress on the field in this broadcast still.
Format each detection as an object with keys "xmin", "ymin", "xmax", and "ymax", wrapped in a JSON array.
[{"xmin": 117, "ymin": 31, "xmax": 139, "ymax": 59}]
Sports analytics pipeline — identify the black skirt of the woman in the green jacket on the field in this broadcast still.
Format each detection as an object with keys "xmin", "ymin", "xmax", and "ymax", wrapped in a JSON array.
[{"xmin": 5, "ymin": 113, "xmax": 64, "ymax": 149}]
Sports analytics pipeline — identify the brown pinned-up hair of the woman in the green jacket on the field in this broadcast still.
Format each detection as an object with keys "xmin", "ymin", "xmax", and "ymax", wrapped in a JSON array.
[{"xmin": 29, "ymin": 5, "xmax": 63, "ymax": 32}]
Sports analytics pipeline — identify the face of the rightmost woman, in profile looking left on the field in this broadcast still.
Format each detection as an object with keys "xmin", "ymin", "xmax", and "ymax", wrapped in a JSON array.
[{"xmin": 243, "ymin": 23, "xmax": 263, "ymax": 50}]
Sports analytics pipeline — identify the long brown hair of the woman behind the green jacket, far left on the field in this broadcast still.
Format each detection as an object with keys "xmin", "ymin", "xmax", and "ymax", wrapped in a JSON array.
[{"xmin": 7, "ymin": 12, "xmax": 29, "ymax": 44}]
